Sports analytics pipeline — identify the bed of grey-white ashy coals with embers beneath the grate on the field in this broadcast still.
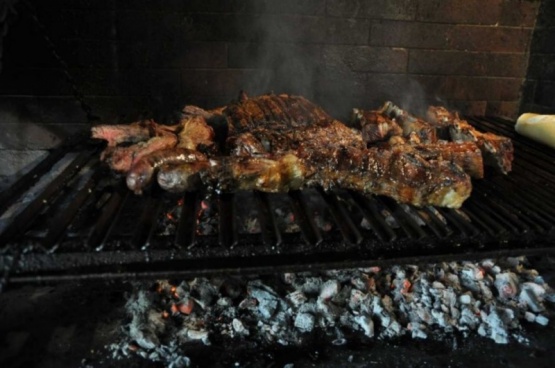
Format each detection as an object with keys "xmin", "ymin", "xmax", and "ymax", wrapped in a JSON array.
[{"xmin": 112, "ymin": 257, "xmax": 555, "ymax": 367}]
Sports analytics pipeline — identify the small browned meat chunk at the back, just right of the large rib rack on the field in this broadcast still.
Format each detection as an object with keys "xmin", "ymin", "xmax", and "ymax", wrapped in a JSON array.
[{"xmin": 351, "ymin": 109, "xmax": 403, "ymax": 143}]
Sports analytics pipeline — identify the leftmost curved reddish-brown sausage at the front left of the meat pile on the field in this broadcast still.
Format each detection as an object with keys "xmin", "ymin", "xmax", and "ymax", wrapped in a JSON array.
[{"xmin": 126, "ymin": 147, "xmax": 206, "ymax": 194}]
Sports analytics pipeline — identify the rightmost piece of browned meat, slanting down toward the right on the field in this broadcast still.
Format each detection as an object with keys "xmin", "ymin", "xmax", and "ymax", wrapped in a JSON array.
[{"xmin": 428, "ymin": 106, "xmax": 514, "ymax": 174}]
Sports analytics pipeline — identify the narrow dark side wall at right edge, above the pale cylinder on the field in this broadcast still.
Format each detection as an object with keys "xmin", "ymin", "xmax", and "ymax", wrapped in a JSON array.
[{"xmin": 521, "ymin": 1, "xmax": 555, "ymax": 114}]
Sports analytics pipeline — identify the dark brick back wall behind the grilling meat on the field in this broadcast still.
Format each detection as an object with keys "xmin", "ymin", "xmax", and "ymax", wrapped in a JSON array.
[{"xmin": 0, "ymin": 0, "xmax": 548, "ymax": 187}]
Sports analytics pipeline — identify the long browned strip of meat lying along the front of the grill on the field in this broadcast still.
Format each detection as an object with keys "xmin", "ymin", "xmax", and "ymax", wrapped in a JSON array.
[{"xmin": 158, "ymin": 147, "xmax": 472, "ymax": 208}]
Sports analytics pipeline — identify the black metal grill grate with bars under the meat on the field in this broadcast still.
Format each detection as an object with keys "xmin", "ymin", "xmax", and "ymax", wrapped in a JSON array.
[{"xmin": 0, "ymin": 118, "xmax": 555, "ymax": 283}]
